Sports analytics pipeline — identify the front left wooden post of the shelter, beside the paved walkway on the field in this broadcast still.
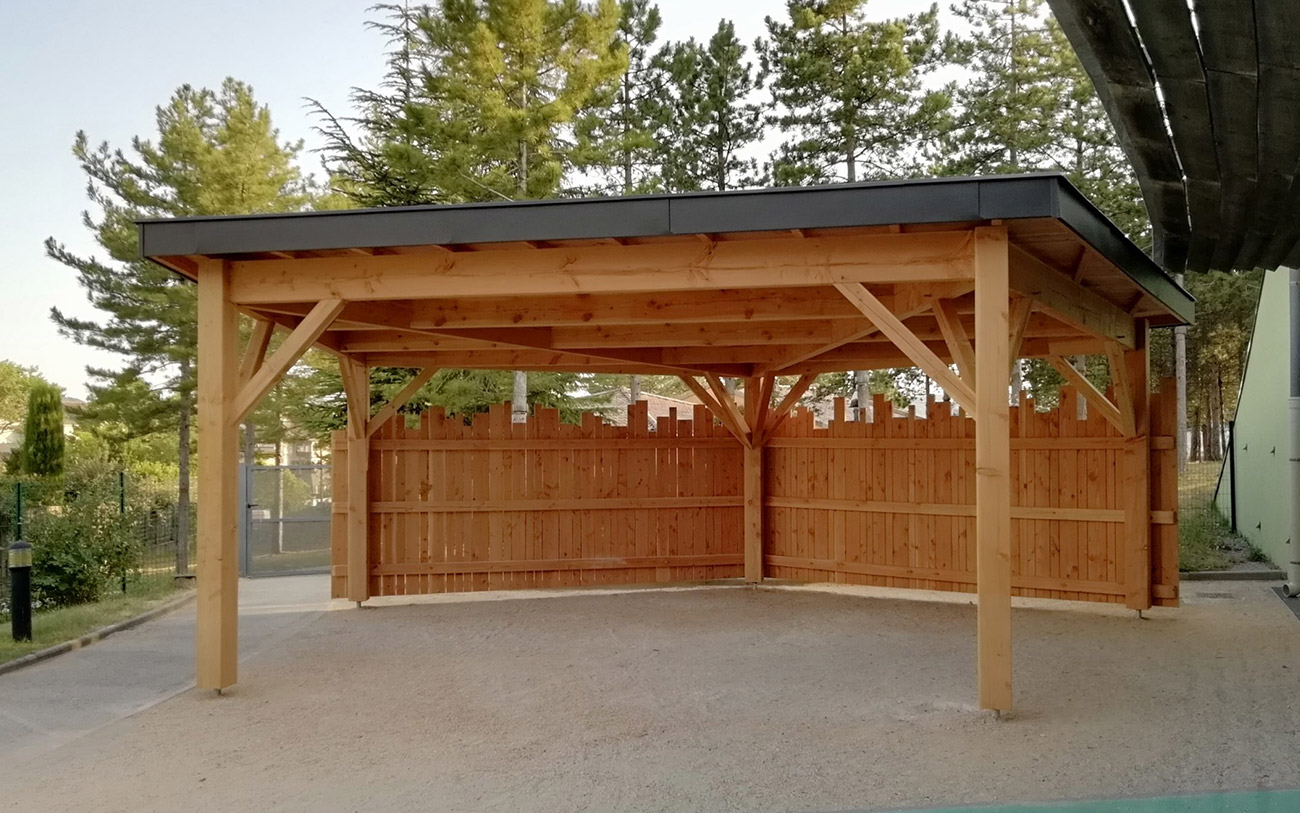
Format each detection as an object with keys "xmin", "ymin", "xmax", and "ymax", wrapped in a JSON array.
[{"xmin": 195, "ymin": 259, "xmax": 239, "ymax": 692}]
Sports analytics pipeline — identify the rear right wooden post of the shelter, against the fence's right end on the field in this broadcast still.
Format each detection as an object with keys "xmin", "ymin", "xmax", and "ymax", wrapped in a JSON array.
[{"xmin": 1121, "ymin": 319, "xmax": 1151, "ymax": 610}]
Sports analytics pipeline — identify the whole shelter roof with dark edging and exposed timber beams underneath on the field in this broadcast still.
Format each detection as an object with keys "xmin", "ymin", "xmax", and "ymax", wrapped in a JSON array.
[{"xmin": 140, "ymin": 174, "xmax": 1192, "ymax": 376}]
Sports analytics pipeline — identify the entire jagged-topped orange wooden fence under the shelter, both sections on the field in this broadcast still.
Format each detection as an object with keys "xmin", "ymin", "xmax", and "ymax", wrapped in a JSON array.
[{"xmin": 333, "ymin": 388, "xmax": 1178, "ymax": 605}]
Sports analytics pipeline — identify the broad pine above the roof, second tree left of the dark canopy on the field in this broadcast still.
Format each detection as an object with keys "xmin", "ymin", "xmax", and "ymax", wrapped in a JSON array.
[{"xmin": 757, "ymin": 0, "xmax": 950, "ymax": 183}]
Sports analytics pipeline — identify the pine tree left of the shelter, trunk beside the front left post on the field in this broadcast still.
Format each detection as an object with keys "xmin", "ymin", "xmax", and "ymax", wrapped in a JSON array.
[{"xmin": 46, "ymin": 79, "xmax": 317, "ymax": 565}]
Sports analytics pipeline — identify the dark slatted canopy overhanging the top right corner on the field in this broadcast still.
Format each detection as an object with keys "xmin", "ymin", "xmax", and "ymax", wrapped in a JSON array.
[{"xmin": 1049, "ymin": 0, "xmax": 1300, "ymax": 272}]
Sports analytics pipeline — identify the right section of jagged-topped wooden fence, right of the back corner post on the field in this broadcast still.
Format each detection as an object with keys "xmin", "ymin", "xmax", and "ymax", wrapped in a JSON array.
[{"xmin": 764, "ymin": 388, "xmax": 1178, "ymax": 605}]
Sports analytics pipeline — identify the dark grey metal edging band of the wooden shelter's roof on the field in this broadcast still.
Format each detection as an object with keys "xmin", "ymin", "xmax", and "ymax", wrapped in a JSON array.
[{"xmin": 139, "ymin": 173, "xmax": 1193, "ymax": 324}]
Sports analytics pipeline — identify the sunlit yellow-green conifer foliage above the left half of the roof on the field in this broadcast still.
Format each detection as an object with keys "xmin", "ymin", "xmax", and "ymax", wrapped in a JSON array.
[{"xmin": 316, "ymin": 0, "xmax": 628, "ymax": 206}]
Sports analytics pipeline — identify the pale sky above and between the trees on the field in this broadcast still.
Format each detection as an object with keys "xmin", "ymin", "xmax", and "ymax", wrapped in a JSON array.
[{"xmin": 0, "ymin": 0, "xmax": 946, "ymax": 398}]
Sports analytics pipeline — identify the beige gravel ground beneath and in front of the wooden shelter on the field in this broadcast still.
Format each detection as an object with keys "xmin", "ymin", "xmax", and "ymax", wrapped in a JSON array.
[{"xmin": 0, "ymin": 581, "xmax": 1300, "ymax": 810}]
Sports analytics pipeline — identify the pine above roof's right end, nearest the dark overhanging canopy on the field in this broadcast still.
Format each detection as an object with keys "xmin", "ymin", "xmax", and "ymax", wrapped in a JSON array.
[{"xmin": 940, "ymin": 0, "xmax": 1062, "ymax": 174}]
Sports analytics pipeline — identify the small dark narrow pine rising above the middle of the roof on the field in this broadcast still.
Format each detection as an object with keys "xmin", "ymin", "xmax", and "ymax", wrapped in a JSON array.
[{"xmin": 657, "ymin": 20, "xmax": 763, "ymax": 191}]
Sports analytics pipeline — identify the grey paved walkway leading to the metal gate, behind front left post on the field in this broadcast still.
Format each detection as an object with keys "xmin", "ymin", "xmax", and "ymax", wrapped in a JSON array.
[{"xmin": 0, "ymin": 575, "xmax": 330, "ymax": 777}]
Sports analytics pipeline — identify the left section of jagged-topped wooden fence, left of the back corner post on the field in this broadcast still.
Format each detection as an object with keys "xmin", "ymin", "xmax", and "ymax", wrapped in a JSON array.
[{"xmin": 333, "ymin": 402, "xmax": 744, "ymax": 597}]
